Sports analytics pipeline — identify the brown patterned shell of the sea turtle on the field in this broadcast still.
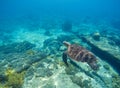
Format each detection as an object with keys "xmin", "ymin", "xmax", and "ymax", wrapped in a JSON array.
[{"xmin": 67, "ymin": 44, "xmax": 98, "ymax": 70}]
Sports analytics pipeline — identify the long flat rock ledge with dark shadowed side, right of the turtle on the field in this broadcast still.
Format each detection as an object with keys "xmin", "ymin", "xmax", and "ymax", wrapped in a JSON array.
[{"xmin": 81, "ymin": 36, "xmax": 120, "ymax": 74}]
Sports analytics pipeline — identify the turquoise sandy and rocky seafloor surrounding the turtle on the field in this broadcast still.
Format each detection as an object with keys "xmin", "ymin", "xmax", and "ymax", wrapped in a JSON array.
[{"xmin": 0, "ymin": 18, "xmax": 120, "ymax": 88}]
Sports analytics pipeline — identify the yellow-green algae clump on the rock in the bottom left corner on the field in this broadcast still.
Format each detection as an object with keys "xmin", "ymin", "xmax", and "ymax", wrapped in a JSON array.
[{"xmin": 0, "ymin": 69, "xmax": 25, "ymax": 88}]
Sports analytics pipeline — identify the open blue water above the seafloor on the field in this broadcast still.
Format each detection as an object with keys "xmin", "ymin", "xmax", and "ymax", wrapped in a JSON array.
[{"xmin": 0, "ymin": 0, "xmax": 120, "ymax": 33}]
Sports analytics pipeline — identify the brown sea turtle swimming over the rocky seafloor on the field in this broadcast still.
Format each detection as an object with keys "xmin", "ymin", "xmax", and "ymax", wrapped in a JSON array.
[{"xmin": 62, "ymin": 41, "xmax": 99, "ymax": 70}]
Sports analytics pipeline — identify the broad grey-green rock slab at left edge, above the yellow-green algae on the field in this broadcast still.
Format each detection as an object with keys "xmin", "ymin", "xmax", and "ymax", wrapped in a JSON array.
[{"xmin": 0, "ymin": 43, "xmax": 47, "ymax": 76}]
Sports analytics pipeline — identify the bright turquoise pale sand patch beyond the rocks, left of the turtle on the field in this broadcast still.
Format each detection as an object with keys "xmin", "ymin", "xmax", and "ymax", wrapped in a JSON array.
[{"xmin": 12, "ymin": 28, "xmax": 70, "ymax": 48}]
